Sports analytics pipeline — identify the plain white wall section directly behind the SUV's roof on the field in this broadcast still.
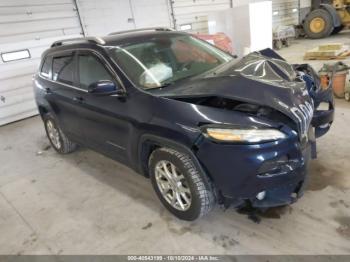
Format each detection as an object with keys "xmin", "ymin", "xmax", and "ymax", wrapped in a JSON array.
[{"xmin": 77, "ymin": 0, "xmax": 171, "ymax": 36}]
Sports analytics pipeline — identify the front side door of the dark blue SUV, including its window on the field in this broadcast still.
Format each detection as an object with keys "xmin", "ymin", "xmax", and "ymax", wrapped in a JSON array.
[{"xmin": 77, "ymin": 51, "xmax": 130, "ymax": 162}]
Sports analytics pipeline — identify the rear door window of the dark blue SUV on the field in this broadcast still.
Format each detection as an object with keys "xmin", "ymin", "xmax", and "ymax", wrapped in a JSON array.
[{"xmin": 52, "ymin": 55, "xmax": 75, "ymax": 85}]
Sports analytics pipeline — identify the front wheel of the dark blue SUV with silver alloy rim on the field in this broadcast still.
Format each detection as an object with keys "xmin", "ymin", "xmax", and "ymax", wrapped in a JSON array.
[{"xmin": 149, "ymin": 148, "xmax": 216, "ymax": 221}]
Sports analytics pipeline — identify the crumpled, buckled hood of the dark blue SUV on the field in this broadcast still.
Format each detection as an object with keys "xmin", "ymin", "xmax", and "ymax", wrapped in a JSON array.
[{"xmin": 162, "ymin": 50, "xmax": 313, "ymax": 134}]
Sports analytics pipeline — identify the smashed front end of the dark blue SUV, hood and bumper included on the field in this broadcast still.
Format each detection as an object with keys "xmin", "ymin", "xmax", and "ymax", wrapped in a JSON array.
[{"xmin": 157, "ymin": 50, "xmax": 334, "ymax": 208}]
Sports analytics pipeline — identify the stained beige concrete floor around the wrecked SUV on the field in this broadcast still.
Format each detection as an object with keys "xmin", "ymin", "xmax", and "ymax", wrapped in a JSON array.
[{"xmin": 0, "ymin": 33, "xmax": 350, "ymax": 254}]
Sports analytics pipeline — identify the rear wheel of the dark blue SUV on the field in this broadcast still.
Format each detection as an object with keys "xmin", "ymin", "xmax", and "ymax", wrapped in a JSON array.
[{"xmin": 43, "ymin": 114, "xmax": 78, "ymax": 154}]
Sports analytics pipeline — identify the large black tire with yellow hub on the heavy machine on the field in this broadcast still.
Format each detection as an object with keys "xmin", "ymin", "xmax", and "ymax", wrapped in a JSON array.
[{"xmin": 303, "ymin": 9, "xmax": 334, "ymax": 39}]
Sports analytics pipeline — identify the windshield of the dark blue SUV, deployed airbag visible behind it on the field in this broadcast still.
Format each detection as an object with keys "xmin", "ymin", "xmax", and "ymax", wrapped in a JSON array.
[{"xmin": 109, "ymin": 35, "xmax": 233, "ymax": 89}]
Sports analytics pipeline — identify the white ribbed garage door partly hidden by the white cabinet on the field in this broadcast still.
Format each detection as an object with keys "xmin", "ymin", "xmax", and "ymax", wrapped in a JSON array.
[{"xmin": 172, "ymin": 0, "xmax": 232, "ymax": 33}]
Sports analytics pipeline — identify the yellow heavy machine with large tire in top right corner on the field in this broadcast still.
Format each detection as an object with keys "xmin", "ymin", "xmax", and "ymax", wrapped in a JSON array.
[{"xmin": 303, "ymin": 0, "xmax": 350, "ymax": 39}]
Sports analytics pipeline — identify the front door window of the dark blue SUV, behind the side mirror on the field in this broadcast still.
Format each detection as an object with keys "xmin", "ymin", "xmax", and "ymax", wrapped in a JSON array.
[{"xmin": 78, "ymin": 54, "xmax": 113, "ymax": 89}]
